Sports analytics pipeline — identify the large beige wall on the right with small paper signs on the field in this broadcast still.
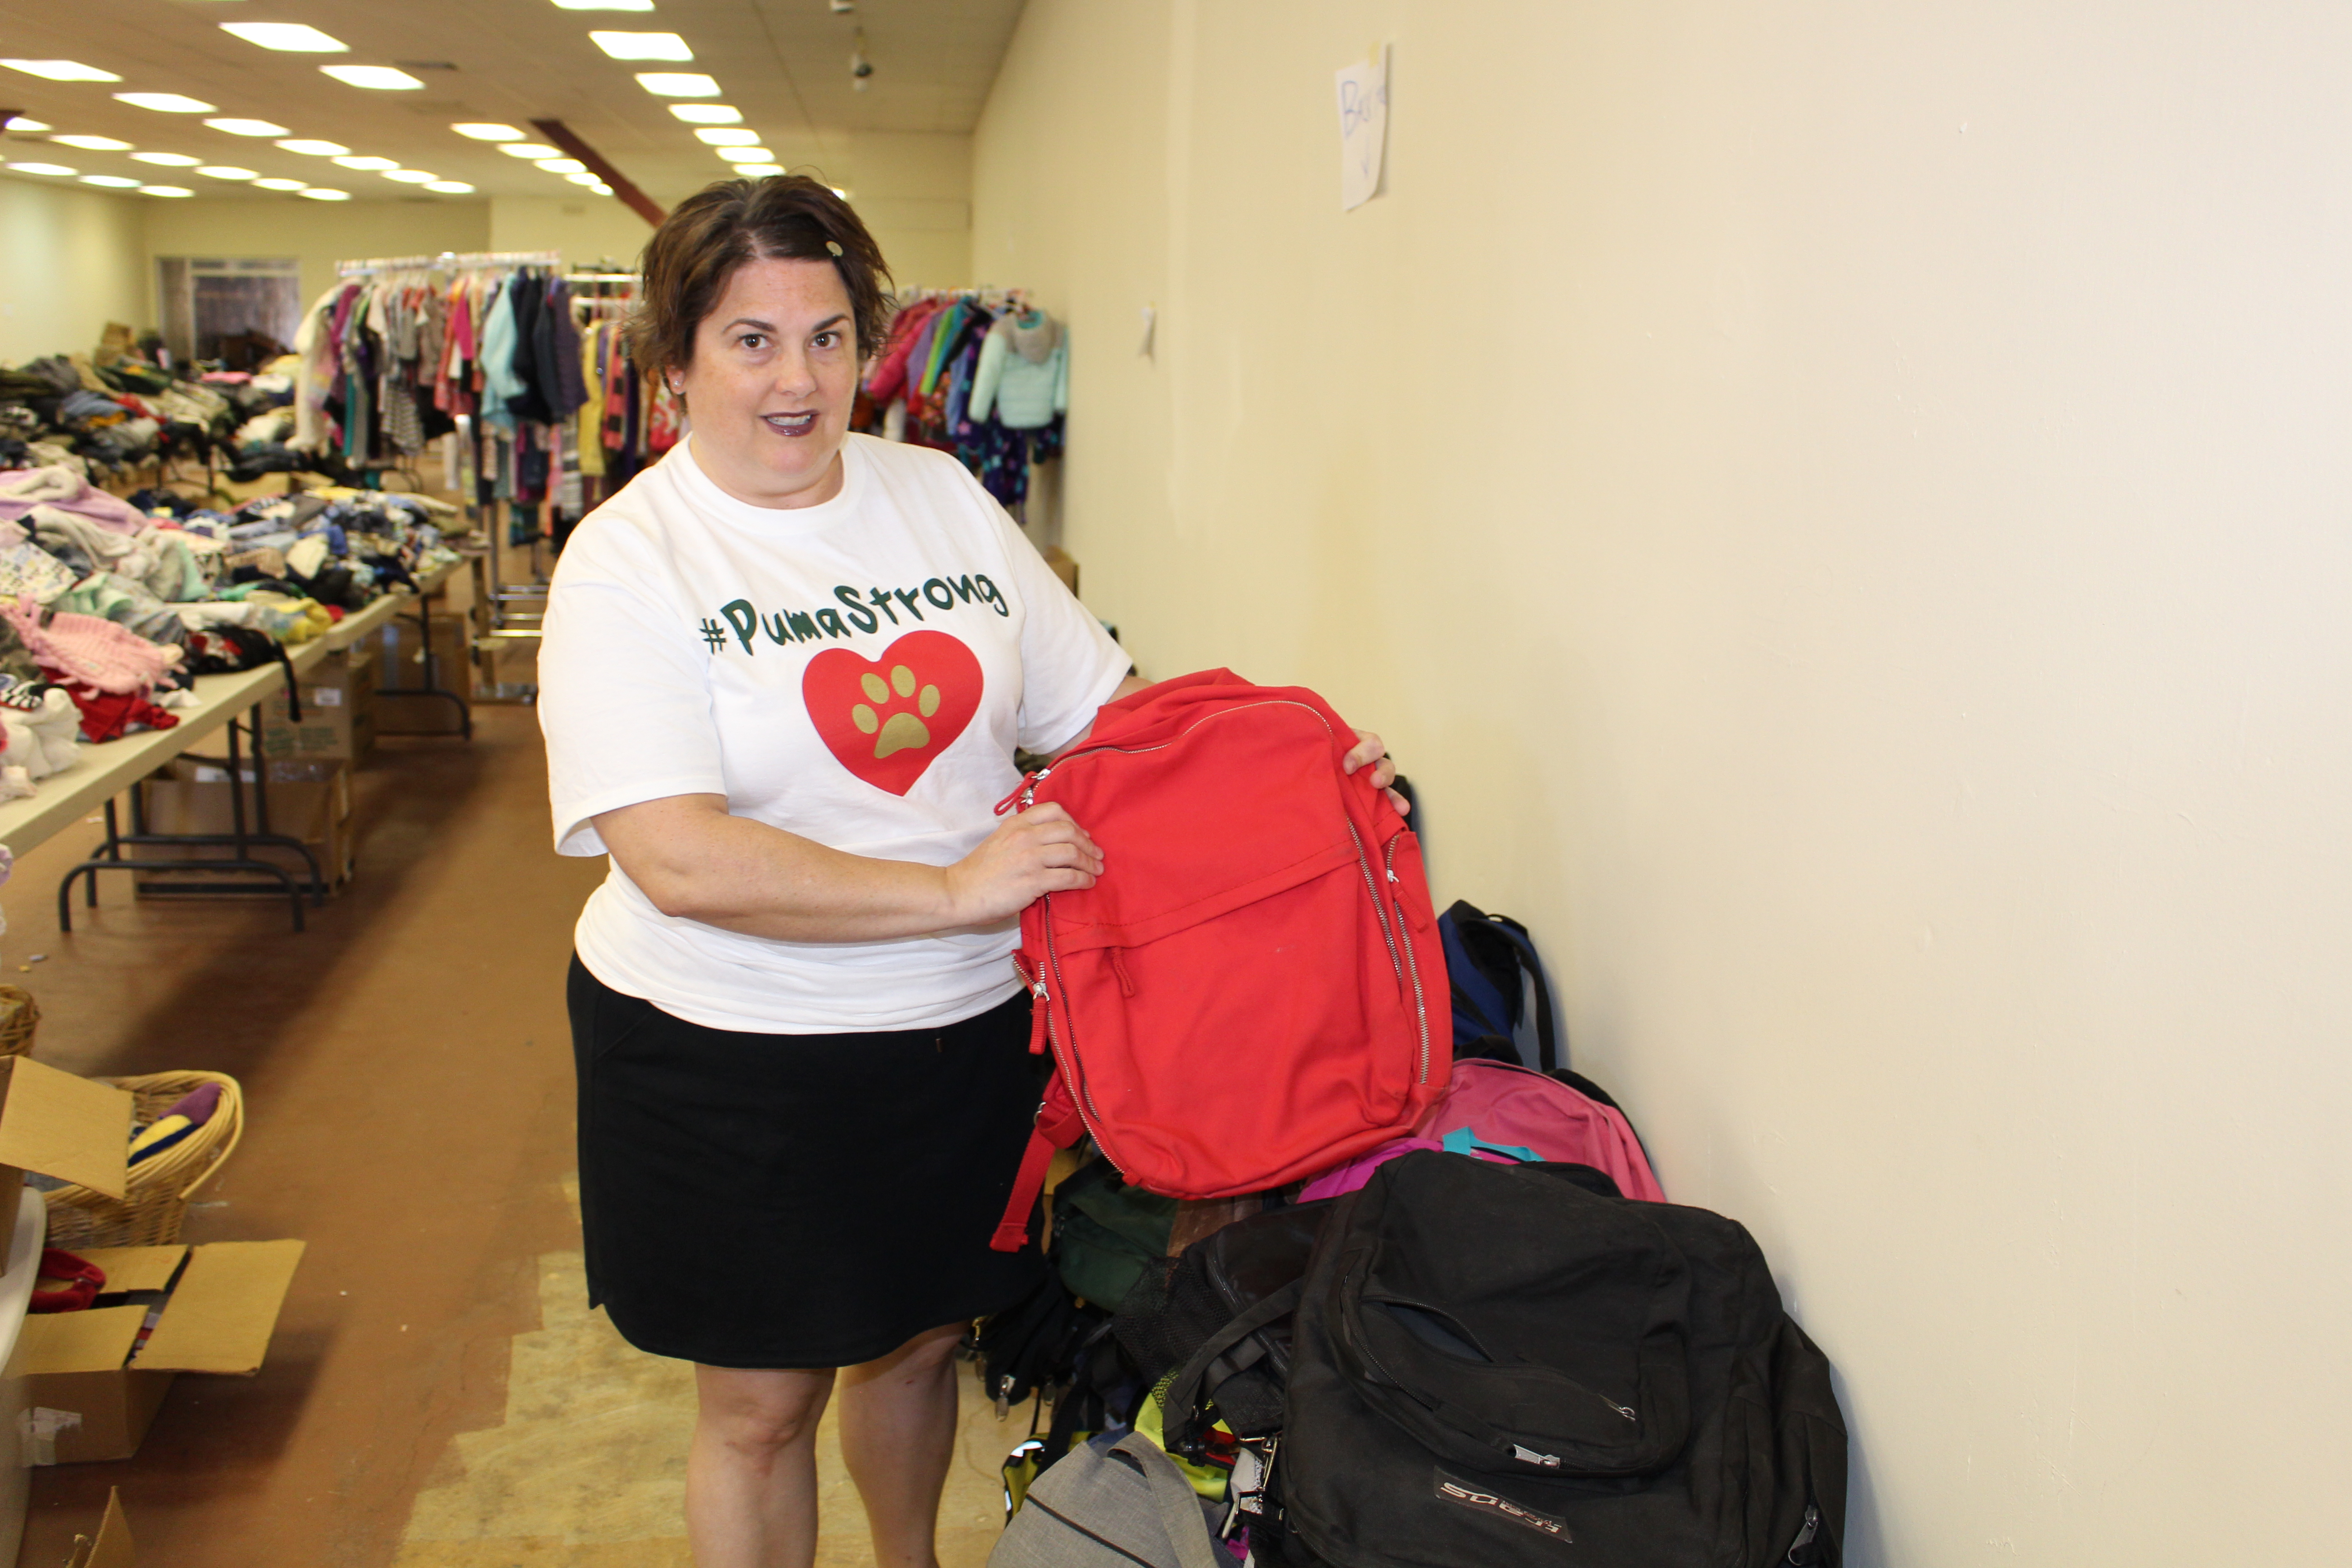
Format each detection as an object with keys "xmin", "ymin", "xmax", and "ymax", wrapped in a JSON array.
[{"xmin": 974, "ymin": 0, "xmax": 2352, "ymax": 1568}]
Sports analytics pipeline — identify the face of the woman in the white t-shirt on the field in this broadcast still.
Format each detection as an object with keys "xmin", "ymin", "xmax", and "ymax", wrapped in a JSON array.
[{"xmin": 675, "ymin": 259, "xmax": 858, "ymax": 505}]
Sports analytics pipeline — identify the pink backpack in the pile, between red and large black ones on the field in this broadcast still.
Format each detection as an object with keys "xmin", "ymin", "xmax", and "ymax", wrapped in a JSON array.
[{"xmin": 1298, "ymin": 1058, "xmax": 1665, "ymax": 1204}]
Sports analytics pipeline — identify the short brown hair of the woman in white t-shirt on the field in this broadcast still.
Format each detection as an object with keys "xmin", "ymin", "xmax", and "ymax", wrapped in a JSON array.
[{"xmin": 628, "ymin": 174, "xmax": 892, "ymax": 376}]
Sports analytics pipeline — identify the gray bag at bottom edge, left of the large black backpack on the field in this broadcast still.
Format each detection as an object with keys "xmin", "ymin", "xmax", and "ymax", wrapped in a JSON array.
[{"xmin": 988, "ymin": 1431, "xmax": 1232, "ymax": 1568}]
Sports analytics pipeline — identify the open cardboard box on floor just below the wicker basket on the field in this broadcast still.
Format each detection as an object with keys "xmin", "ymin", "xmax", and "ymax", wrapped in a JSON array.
[{"xmin": 7, "ymin": 1241, "xmax": 304, "ymax": 1465}]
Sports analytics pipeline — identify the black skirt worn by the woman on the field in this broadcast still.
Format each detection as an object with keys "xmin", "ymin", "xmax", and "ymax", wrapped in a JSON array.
[{"xmin": 569, "ymin": 957, "xmax": 1044, "ymax": 1368}]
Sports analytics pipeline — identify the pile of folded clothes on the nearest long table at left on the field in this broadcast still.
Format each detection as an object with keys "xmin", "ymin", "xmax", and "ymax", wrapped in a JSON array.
[{"xmin": 0, "ymin": 466, "xmax": 456, "ymax": 799}]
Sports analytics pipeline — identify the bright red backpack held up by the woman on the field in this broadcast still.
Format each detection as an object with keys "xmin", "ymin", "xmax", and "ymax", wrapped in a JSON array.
[{"xmin": 990, "ymin": 670, "xmax": 1454, "ymax": 1253}]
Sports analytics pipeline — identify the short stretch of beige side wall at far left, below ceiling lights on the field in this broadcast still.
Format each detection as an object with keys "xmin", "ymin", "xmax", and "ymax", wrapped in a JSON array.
[{"xmin": 0, "ymin": 176, "xmax": 155, "ymax": 364}]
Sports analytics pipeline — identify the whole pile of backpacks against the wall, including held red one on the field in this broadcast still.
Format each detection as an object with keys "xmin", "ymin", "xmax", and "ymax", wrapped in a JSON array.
[{"xmin": 974, "ymin": 670, "xmax": 1846, "ymax": 1568}]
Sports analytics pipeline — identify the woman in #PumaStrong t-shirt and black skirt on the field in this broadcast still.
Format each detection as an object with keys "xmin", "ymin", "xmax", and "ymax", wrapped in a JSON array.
[{"xmin": 539, "ymin": 176, "xmax": 1392, "ymax": 1568}]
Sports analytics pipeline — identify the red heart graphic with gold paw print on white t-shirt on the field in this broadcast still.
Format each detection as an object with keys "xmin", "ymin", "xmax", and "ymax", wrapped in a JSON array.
[{"xmin": 800, "ymin": 632, "xmax": 985, "ymax": 794}]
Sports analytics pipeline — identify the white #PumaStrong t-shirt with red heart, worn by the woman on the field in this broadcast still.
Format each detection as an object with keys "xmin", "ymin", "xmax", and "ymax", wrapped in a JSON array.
[{"xmin": 539, "ymin": 435, "xmax": 1127, "ymax": 1034}]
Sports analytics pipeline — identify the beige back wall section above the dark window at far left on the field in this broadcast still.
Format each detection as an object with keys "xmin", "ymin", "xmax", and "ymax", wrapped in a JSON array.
[{"xmin": 146, "ymin": 195, "xmax": 489, "ymax": 317}]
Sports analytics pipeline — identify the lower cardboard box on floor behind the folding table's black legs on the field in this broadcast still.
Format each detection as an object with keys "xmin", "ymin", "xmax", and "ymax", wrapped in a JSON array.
[{"xmin": 125, "ymin": 757, "xmax": 358, "ymax": 898}]
